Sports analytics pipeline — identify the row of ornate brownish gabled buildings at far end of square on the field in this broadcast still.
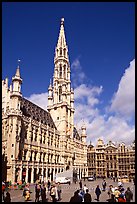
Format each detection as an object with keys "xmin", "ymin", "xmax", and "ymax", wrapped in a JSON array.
[{"xmin": 87, "ymin": 139, "xmax": 135, "ymax": 177}]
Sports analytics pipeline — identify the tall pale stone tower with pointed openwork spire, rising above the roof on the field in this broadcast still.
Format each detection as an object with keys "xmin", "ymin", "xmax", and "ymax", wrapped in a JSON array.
[{"xmin": 47, "ymin": 18, "xmax": 74, "ymax": 136}]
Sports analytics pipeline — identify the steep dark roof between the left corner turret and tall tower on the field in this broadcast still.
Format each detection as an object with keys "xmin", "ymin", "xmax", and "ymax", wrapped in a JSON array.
[{"xmin": 21, "ymin": 98, "xmax": 57, "ymax": 129}]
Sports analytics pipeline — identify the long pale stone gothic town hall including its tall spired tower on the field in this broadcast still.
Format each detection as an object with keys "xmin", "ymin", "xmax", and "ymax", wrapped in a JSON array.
[{"xmin": 2, "ymin": 19, "xmax": 88, "ymax": 183}]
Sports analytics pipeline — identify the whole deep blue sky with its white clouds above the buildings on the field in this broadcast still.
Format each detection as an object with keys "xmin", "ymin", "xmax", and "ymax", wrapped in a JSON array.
[{"xmin": 2, "ymin": 2, "xmax": 135, "ymax": 144}]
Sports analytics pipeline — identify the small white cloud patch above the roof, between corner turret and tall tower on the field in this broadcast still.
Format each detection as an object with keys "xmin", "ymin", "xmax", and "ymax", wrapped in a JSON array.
[{"xmin": 26, "ymin": 92, "xmax": 48, "ymax": 110}]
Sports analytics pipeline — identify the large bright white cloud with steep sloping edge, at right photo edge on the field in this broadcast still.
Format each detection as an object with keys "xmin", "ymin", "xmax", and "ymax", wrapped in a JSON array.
[{"xmin": 110, "ymin": 60, "xmax": 135, "ymax": 118}]
